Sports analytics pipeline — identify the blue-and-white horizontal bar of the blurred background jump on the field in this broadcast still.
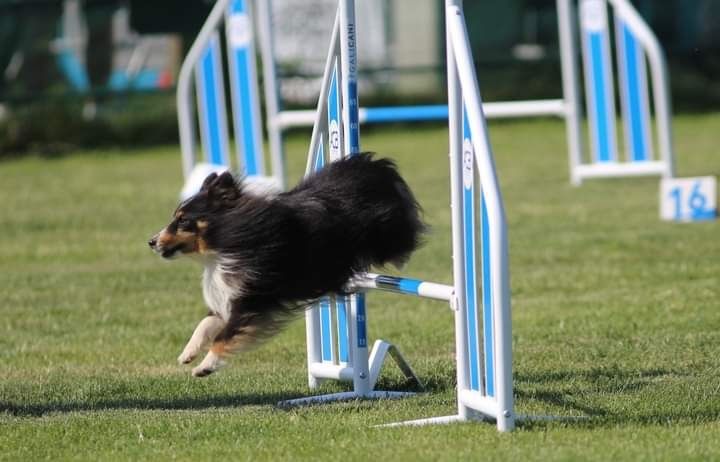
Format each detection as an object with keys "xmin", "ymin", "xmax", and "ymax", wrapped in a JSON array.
[{"xmin": 275, "ymin": 99, "xmax": 566, "ymax": 128}]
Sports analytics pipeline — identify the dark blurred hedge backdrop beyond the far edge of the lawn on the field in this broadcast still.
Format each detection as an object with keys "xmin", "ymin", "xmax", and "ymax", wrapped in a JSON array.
[{"xmin": 0, "ymin": 0, "xmax": 720, "ymax": 158}]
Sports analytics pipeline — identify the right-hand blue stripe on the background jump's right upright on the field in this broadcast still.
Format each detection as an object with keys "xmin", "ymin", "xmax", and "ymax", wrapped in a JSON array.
[{"xmin": 622, "ymin": 23, "xmax": 650, "ymax": 162}]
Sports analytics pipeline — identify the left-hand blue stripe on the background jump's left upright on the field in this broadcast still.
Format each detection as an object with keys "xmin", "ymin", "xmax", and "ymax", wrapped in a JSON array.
[{"xmin": 199, "ymin": 37, "xmax": 228, "ymax": 165}]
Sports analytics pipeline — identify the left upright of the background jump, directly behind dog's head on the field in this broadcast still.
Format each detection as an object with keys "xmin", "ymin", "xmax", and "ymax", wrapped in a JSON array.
[{"xmin": 177, "ymin": 0, "xmax": 285, "ymax": 195}]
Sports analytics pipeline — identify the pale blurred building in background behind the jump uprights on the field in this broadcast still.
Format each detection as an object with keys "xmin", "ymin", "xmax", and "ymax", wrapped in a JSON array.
[{"xmin": 272, "ymin": 0, "xmax": 443, "ymax": 103}]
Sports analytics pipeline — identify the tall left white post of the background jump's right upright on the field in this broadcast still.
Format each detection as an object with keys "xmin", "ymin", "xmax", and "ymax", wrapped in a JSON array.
[{"xmin": 557, "ymin": 0, "xmax": 582, "ymax": 185}]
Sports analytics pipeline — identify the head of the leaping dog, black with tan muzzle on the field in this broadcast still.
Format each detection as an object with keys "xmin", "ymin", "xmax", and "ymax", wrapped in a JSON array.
[{"xmin": 148, "ymin": 172, "xmax": 242, "ymax": 258}]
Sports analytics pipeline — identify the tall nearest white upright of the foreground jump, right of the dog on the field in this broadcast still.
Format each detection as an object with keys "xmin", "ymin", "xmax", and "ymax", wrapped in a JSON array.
[{"xmin": 390, "ymin": 0, "xmax": 515, "ymax": 431}]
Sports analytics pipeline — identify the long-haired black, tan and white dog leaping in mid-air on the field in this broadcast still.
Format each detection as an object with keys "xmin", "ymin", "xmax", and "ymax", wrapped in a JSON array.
[{"xmin": 148, "ymin": 153, "xmax": 426, "ymax": 377}]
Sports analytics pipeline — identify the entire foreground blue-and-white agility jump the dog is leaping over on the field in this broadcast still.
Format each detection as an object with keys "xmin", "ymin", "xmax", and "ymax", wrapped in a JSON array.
[{"xmin": 281, "ymin": 0, "xmax": 515, "ymax": 431}]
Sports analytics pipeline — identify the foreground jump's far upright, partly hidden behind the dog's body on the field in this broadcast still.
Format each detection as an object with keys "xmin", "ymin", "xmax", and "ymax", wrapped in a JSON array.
[{"xmin": 278, "ymin": 0, "xmax": 421, "ymax": 407}]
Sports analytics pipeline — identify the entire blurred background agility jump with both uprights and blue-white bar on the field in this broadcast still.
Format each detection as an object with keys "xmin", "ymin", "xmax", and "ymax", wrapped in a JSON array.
[{"xmin": 177, "ymin": 0, "xmax": 674, "ymax": 186}]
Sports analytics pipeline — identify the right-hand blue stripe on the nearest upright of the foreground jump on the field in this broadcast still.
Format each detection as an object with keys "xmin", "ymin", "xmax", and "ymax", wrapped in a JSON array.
[{"xmin": 480, "ymin": 194, "xmax": 495, "ymax": 396}]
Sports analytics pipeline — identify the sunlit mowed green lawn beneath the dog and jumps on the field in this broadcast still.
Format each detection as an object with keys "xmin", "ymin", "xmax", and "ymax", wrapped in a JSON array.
[{"xmin": 0, "ymin": 115, "xmax": 720, "ymax": 461}]
